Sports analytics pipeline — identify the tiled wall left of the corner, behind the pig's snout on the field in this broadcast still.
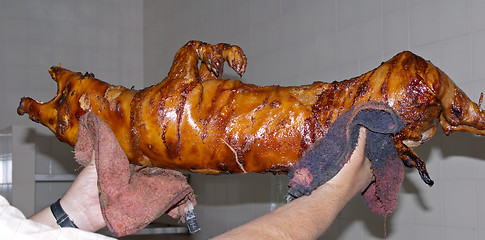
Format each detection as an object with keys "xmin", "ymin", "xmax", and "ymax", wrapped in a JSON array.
[{"xmin": 0, "ymin": 0, "xmax": 143, "ymax": 212}]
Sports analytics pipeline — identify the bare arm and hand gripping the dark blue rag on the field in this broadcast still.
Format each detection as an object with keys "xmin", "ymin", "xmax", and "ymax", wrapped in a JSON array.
[{"xmin": 215, "ymin": 128, "xmax": 373, "ymax": 239}]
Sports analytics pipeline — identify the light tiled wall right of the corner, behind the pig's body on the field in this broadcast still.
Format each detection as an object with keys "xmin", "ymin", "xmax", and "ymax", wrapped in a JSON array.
[{"xmin": 144, "ymin": 0, "xmax": 485, "ymax": 239}]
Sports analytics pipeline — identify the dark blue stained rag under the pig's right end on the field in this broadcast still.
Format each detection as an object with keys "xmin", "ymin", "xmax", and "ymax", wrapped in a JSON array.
[{"xmin": 287, "ymin": 102, "xmax": 404, "ymax": 216}]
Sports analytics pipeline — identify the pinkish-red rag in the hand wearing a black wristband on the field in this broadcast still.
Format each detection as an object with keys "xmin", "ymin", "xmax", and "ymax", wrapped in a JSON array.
[{"xmin": 74, "ymin": 113, "xmax": 198, "ymax": 237}]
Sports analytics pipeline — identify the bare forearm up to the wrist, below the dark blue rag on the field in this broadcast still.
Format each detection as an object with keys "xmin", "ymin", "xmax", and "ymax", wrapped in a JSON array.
[{"xmin": 214, "ymin": 184, "xmax": 353, "ymax": 239}]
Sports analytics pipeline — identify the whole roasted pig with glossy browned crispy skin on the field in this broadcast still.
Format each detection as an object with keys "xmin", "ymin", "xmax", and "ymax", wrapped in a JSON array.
[{"xmin": 18, "ymin": 41, "xmax": 485, "ymax": 184}]
